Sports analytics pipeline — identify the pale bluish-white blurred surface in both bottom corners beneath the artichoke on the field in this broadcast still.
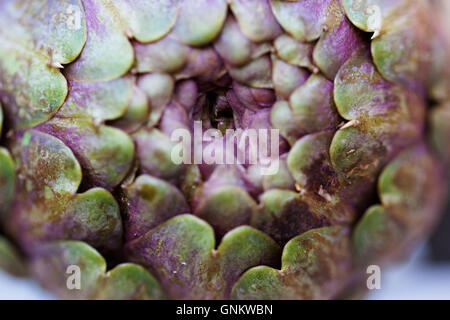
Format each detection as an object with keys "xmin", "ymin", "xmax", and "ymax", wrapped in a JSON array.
[{"xmin": 0, "ymin": 247, "xmax": 450, "ymax": 300}]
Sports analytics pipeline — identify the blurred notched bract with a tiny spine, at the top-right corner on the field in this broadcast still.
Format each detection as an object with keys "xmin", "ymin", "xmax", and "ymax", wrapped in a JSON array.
[{"xmin": 343, "ymin": 0, "xmax": 433, "ymax": 94}]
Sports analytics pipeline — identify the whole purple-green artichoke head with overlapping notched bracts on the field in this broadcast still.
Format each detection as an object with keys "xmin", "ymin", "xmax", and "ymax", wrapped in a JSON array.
[{"xmin": 0, "ymin": 0, "xmax": 450, "ymax": 299}]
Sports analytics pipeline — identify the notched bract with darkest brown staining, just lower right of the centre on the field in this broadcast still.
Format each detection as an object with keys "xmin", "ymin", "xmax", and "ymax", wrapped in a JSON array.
[{"xmin": 252, "ymin": 132, "xmax": 355, "ymax": 243}]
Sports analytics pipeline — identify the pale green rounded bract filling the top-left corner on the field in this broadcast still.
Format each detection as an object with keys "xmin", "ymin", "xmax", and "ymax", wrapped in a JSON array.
[{"xmin": 1, "ymin": 0, "xmax": 86, "ymax": 63}]
